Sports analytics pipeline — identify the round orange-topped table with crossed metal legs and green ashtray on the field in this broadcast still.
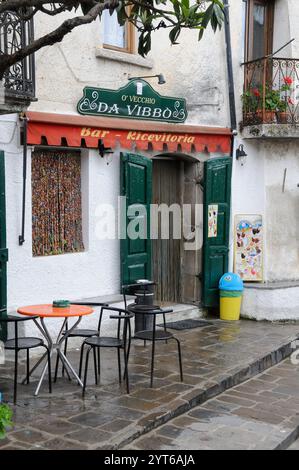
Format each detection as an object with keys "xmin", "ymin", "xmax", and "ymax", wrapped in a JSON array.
[{"xmin": 18, "ymin": 304, "xmax": 93, "ymax": 396}]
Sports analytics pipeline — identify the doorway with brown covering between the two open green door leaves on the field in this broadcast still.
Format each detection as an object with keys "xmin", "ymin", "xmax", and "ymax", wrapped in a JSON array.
[{"xmin": 152, "ymin": 156, "xmax": 203, "ymax": 305}]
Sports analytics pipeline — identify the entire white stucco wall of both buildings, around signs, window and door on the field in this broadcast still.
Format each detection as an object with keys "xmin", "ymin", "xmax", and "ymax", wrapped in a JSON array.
[{"xmin": 0, "ymin": 0, "xmax": 299, "ymax": 324}]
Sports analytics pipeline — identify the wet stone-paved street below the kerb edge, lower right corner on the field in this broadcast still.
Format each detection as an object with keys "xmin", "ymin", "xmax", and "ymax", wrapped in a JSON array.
[{"xmin": 126, "ymin": 359, "xmax": 299, "ymax": 450}]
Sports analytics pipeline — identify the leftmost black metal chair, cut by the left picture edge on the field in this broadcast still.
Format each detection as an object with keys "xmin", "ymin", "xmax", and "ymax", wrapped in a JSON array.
[{"xmin": 0, "ymin": 310, "xmax": 52, "ymax": 404}]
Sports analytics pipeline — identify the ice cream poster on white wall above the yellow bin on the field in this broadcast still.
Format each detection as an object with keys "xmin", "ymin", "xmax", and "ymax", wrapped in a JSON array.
[{"xmin": 234, "ymin": 215, "xmax": 263, "ymax": 281}]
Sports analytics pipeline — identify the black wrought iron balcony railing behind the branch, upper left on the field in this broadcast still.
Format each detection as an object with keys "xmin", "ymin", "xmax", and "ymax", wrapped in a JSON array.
[{"xmin": 0, "ymin": 11, "xmax": 35, "ymax": 100}]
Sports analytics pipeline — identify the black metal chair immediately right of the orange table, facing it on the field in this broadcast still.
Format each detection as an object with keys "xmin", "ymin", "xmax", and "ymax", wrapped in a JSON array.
[{"xmin": 79, "ymin": 307, "xmax": 133, "ymax": 396}]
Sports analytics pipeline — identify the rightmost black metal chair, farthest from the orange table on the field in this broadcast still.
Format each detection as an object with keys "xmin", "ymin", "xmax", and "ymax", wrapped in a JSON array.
[{"xmin": 130, "ymin": 305, "xmax": 184, "ymax": 387}]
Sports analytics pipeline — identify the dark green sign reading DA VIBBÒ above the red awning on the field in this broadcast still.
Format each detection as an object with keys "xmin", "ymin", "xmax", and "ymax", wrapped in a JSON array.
[{"xmin": 77, "ymin": 79, "xmax": 187, "ymax": 123}]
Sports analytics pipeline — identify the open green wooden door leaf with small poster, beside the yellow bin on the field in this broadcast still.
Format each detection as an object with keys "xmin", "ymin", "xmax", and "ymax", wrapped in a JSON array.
[{"xmin": 202, "ymin": 158, "xmax": 232, "ymax": 307}]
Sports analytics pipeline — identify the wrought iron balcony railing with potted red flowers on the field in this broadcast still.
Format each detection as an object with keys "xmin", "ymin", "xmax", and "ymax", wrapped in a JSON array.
[{"xmin": 242, "ymin": 57, "xmax": 299, "ymax": 126}]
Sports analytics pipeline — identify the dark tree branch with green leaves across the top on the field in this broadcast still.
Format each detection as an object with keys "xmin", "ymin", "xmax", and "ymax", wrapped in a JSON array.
[{"xmin": 0, "ymin": 0, "xmax": 224, "ymax": 80}]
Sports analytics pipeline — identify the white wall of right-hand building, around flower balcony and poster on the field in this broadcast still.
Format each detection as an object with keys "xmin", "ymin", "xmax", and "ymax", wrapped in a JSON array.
[{"xmin": 230, "ymin": 0, "xmax": 299, "ymax": 284}]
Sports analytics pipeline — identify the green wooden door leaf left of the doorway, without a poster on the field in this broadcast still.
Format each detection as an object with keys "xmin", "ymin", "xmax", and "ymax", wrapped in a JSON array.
[{"xmin": 120, "ymin": 153, "xmax": 152, "ymax": 284}]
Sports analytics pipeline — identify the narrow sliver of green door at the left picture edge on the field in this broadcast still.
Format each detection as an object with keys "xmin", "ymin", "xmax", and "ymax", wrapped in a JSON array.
[{"xmin": 0, "ymin": 151, "xmax": 8, "ymax": 341}]
